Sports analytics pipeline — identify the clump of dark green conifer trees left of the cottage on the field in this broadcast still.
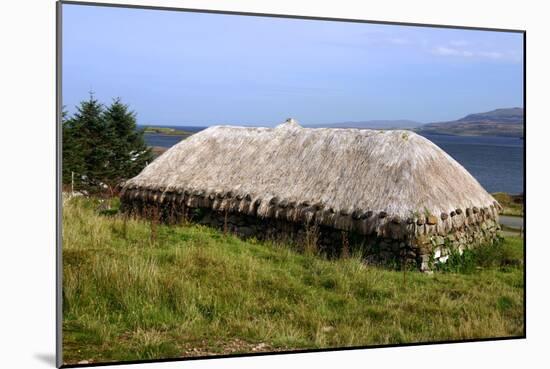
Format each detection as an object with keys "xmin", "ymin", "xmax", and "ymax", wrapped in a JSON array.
[{"xmin": 62, "ymin": 94, "xmax": 153, "ymax": 196}]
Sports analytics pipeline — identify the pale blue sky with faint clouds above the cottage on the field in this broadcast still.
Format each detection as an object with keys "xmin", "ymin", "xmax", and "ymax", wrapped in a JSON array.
[{"xmin": 62, "ymin": 4, "xmax": 523, "ymax": 126}]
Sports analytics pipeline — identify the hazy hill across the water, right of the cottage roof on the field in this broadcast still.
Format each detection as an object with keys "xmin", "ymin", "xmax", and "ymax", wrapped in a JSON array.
[{"xmin": 416, "ymin": 108, "xmax": 524, "ymax": 137}]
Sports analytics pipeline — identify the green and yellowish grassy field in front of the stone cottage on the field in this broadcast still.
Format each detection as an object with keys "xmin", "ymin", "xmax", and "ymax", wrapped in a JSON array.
[{"xmin": 63, "ymin": 198, "xmax": 524, "ymax": 363}]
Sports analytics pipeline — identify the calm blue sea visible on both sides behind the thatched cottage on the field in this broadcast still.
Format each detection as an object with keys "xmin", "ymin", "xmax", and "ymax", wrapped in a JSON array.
[{"xmin": 140, "ymin": 126, "xmax": 524, "ymax": 194}]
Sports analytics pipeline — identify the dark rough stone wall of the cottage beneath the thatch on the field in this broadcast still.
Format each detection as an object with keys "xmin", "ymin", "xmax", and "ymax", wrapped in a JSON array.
[{"xmin": 194, "ymin": 209, "xmax": 500, "ymax": 271}]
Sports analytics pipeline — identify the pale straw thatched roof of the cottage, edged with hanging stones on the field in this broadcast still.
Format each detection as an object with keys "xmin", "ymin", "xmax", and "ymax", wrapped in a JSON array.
[{"xmin": 122, "ymin": 120, "xmax": 499, "ymax": 235}]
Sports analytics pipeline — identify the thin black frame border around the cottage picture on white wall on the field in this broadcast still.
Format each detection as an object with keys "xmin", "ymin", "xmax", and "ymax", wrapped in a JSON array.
[{"xmin": 55, "ymin": 0, "xmax": 527, "ymax": 368}]
